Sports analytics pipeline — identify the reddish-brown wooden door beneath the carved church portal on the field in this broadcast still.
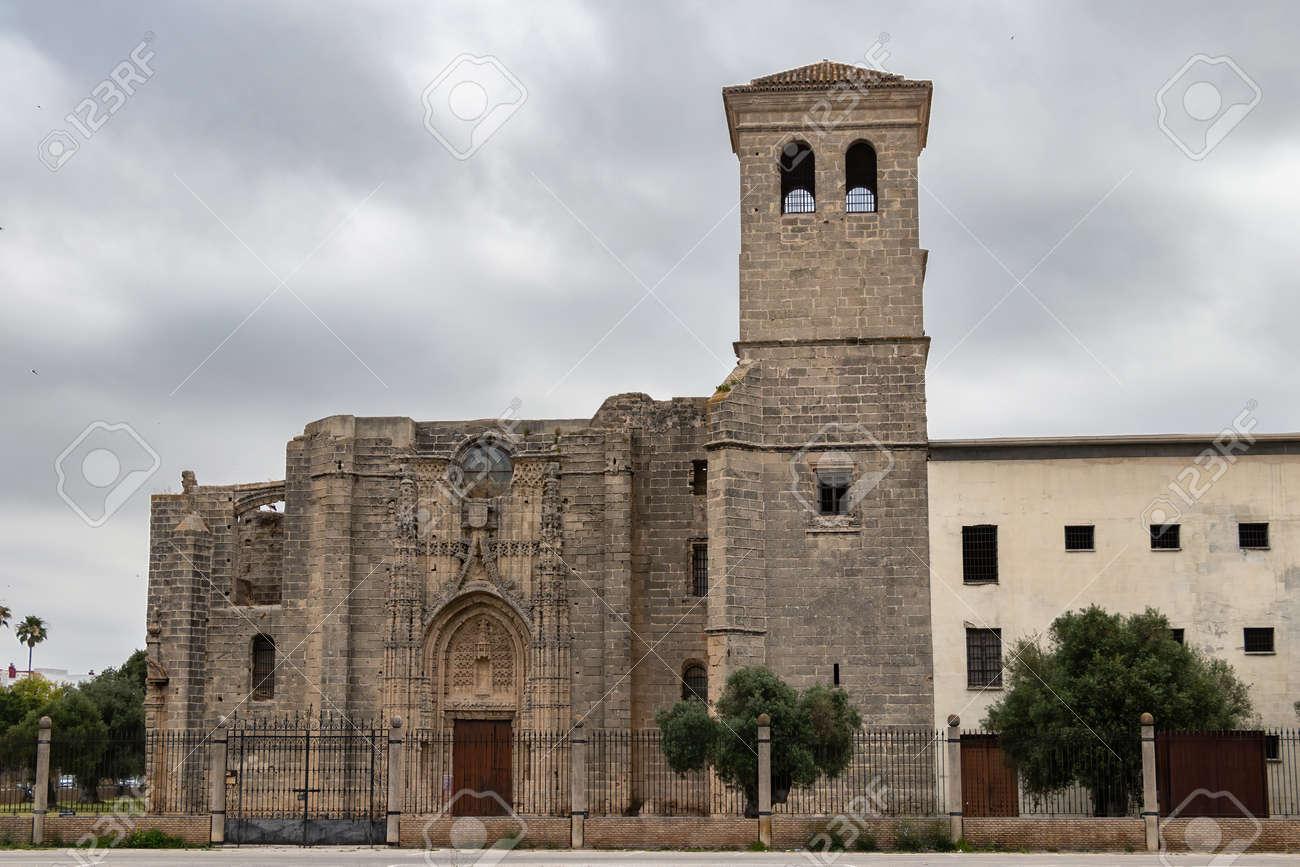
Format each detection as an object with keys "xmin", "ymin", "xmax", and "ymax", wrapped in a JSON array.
[{"xmin": 451, "ymin": 720, "xmax": 514, "ymax": 816}]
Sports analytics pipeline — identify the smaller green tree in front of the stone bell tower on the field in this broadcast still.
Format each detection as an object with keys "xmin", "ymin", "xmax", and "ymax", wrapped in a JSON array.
[{"xmin": 655, "ymin": 667, "xmax": 862, "ymax": 815}]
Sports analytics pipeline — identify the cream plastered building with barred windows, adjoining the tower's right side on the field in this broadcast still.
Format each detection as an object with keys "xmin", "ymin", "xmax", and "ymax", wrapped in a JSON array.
[{"xmin": 930, "ymin": 434, "xmax": 1300, "ymax": 727}]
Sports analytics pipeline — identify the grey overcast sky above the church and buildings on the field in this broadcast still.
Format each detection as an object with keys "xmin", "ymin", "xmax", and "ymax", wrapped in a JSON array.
[{"xmin": 0, "ymin": 0, "xmax": 1300, "ymax": 671}]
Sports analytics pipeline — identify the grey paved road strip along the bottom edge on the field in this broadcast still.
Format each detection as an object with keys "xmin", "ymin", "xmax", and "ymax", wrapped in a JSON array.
[{"xmin": 0, "ymin": 846, "xmax": 1300, "ymax": 867}]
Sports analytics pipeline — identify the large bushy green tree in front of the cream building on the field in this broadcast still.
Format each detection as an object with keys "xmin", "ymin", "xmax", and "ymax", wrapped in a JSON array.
[{"xmin": 984, "ymin": 606, "xmax": 1251, "ymax": 816}]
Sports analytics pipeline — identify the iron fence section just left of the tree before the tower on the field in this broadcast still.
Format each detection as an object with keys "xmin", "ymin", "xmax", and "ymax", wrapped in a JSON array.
[{"xmin": 586, "ymin": 729, "xmax": 745, "ymax": 816}]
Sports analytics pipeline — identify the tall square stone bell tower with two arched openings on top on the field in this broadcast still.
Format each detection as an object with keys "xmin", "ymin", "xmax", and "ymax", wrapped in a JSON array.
[{"xmin": 707, "ymin": 61, "xmax": 933, "ymax": 725}]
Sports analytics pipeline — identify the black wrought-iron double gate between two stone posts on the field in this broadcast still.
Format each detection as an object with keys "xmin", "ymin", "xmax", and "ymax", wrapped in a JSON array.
[{"xmin": 226, "ymin": 725, "xmax": 387, "ymax": 846}]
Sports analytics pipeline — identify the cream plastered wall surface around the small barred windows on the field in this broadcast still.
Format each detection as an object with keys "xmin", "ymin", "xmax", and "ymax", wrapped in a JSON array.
[{"xmin": 930, "ymin": 448, "xmax": 1300, "ymax": 728}]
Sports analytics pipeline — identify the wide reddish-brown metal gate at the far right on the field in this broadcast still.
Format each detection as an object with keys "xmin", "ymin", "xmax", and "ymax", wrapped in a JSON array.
[{"xmin": 1156, "ymin": 732, "xmax": 1269, "ymax": 819}]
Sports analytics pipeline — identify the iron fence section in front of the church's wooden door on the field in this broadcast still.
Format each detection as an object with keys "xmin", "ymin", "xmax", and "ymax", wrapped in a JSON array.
[{"xmin": 403, "ymin": 729, "xmax": 571, "ymax": 816}]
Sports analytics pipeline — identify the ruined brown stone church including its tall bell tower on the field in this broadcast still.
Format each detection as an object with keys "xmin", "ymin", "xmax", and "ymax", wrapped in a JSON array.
[{"xmin": 147, "ymin": 61, "xmax": 935, "ymax": 731}]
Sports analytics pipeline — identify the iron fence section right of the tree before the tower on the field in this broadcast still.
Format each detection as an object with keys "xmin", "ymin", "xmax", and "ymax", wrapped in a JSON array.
[{"xmin": 772, "ymin": 728, "xmax": 948, "ymax": 816}]
